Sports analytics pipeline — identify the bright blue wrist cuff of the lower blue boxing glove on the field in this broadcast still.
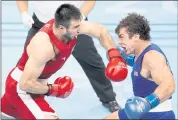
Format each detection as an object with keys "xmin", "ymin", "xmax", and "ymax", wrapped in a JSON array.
[{"xmin": 146, "ymin": 93, "xmax": 160, "ymax": 108}]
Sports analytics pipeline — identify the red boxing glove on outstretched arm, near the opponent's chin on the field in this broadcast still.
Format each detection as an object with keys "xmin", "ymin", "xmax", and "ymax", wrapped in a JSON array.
[{"xmin": 105, "ymin": 48, "xmax": 128, "ymax": 82}]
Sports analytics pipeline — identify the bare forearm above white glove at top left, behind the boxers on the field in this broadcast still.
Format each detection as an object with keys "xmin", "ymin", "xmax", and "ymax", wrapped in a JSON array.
[{"xmin": 16, "ymin": 0, "xmax": 28, "ymax": 13}]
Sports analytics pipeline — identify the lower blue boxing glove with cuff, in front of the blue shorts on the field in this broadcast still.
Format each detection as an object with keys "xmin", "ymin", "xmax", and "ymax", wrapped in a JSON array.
[{"xmin": 125, "ymin": 93, "xmax": 160, "ymax": 119}]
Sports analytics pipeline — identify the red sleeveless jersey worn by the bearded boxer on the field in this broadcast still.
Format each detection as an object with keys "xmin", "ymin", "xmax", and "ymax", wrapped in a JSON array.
[{"xmin": 17, "ymin": 19, "xmax": 76, "ymax": 79}]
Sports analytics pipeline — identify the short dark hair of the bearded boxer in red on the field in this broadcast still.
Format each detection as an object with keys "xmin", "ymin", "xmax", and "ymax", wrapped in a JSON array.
[{"xmin": 55, "ymin": 4, "xmax": 82, "ymax": 28}]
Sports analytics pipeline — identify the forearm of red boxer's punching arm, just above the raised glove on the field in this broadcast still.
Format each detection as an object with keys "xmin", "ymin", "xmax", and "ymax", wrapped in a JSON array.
[{"xmin": 99, "ymin": 27, "xmax": 116, "ymax": 50}]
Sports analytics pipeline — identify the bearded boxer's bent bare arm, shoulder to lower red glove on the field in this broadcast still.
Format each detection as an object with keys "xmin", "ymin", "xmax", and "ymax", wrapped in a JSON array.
[{"xmin": 19, "ymin": 32, "xmax": 54, "ymax": 94}]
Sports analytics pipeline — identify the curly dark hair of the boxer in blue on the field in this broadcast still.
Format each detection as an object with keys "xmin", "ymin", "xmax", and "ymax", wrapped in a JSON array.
[{"xmin": 115, "ymin": 13, "xmax": 150, "ymax": 40}]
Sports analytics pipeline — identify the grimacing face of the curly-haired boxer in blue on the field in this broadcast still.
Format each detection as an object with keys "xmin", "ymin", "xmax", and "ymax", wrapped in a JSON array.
[{"xmin": 118, "ymin": 28, "xmax": 135, "ymax": 54}]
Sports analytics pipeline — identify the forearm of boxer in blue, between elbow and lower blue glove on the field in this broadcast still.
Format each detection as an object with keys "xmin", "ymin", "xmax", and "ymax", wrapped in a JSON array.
[{"xmin": 154, "ymin": 82, "xmax": 175, "ymax": 102}]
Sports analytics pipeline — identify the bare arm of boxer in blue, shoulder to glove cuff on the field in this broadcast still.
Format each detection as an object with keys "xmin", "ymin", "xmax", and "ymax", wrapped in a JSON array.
[{"xmin": 145, "ymin": 51, "xmax": 175, "ymax": 102}]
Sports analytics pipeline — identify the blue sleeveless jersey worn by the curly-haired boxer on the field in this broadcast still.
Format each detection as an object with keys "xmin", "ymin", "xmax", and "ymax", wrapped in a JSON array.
[{"xmin": 131, "ymin": 44, "xmax": 172, "ymax": 98}]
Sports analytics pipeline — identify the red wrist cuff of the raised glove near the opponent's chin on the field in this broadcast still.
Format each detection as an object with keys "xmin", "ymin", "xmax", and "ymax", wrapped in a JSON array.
[{"xmin": 107, "ymin": 48, "xmax": 121, "ymax": 60}]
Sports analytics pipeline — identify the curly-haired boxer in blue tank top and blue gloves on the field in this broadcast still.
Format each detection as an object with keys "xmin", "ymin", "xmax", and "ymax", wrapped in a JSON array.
[{"xmin": 105, "ymin": 13, "xmax": 175, "ymax": 120}]
